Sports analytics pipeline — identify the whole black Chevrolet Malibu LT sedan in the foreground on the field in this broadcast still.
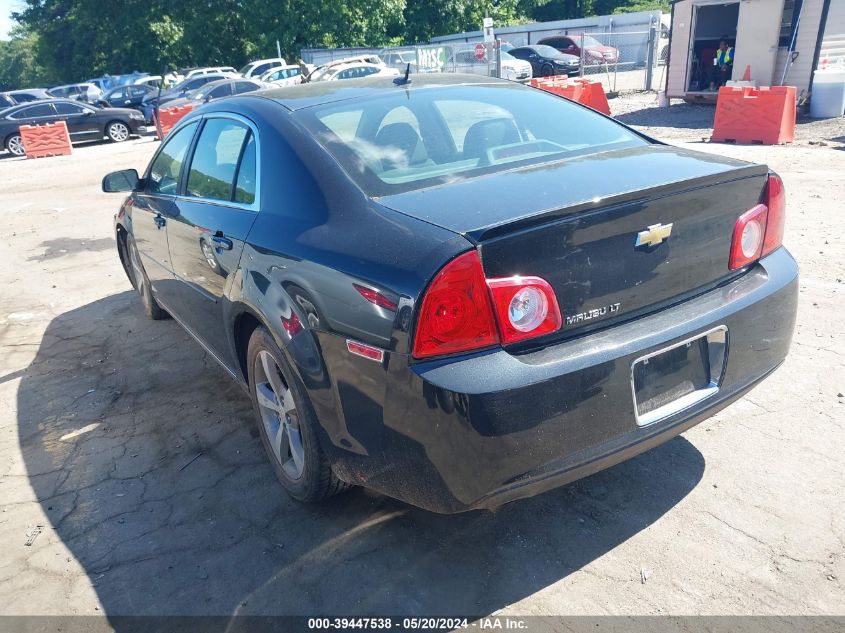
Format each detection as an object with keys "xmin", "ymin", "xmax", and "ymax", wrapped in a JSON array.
[{"xmin": 103, "ymin": 74, "xmax": 798, "ymax": 512}]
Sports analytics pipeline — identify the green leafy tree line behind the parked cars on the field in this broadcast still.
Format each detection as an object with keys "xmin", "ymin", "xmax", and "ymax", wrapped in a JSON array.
[{"xmin": 0, "ymin": 0, "xmax": 669, "ymax": 90}]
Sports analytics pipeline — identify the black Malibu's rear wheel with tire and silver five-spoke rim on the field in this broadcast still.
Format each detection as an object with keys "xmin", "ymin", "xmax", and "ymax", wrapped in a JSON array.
[{"xmin": 247, "ymin": 327, "xmax": 349, "ymax": 501}]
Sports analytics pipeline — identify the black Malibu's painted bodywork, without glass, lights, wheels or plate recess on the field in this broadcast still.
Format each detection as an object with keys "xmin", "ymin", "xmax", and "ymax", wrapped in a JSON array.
[{"xmin": 116, "ymin": 75, "xmax": 798, "ymax": 512}]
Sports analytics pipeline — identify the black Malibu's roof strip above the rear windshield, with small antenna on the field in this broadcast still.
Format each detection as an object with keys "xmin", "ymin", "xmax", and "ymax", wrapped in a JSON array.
[{"xmin": 254, "ymin": 73, "xmax": 508, "ymax": 111}]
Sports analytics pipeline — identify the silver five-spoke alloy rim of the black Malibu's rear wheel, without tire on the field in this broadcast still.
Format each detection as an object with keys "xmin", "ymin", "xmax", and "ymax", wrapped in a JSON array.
[{"xmin": 253, "ymin": 350, "xmax": 305, "ymax": 480}]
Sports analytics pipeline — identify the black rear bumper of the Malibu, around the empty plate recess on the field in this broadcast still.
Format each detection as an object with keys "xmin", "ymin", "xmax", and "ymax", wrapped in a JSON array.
[{"xmin": 330, "ymin": 248, "xmax": 798, "ymax": 512}]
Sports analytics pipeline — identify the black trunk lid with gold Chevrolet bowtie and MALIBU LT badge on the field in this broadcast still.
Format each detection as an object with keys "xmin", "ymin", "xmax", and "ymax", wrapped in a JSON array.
[{"xmin": 381, "ymin": 146, "xmax": 768, "ymax": 346}]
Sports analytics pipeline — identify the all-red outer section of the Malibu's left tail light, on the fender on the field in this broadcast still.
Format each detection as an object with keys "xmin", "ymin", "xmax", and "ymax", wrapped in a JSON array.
[{"xmin": 413, "ymin": 251, "xmax": 499, "ymax": 358}]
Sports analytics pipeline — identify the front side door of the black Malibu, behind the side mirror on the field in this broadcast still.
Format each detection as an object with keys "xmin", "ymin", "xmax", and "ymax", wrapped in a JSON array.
[{"xmin": 131, "ymin": 122, "xmax": 197, "ymax": 309}]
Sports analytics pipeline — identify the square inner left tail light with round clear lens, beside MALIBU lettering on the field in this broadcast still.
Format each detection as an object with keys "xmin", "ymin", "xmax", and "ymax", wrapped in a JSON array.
[{"xmin": 487, "ymin": 277, "xmax": 561, "ymax": 344}]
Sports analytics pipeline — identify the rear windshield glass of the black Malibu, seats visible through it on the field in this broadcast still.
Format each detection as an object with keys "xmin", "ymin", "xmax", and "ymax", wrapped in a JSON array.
[{"xmin": 297, "ymin": 84, "xmax": 648, "ymax": 197}]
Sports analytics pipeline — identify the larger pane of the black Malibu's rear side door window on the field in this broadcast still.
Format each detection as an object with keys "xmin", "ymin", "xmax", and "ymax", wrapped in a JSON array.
[{"xmin": 186, "ymin": 119, "xmax": 250, "ymax": 201}]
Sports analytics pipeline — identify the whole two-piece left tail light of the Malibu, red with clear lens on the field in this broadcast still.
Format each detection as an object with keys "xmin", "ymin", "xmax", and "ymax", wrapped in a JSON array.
[{"xmin": 413, "ymin": 251, "xmax": 561, "ymax": 358}]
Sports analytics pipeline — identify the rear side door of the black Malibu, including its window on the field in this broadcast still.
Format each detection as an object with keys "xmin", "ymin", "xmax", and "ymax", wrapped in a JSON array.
[{"xmin": 167, "ymin": 114, "xmax": 258, "ymax": 370}]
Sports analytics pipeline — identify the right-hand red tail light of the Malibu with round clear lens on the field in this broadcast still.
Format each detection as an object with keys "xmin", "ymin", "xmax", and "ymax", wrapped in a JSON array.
[{"xmin": 728, "ymin": 174, "xmax": 786, "ymax": 270}]
